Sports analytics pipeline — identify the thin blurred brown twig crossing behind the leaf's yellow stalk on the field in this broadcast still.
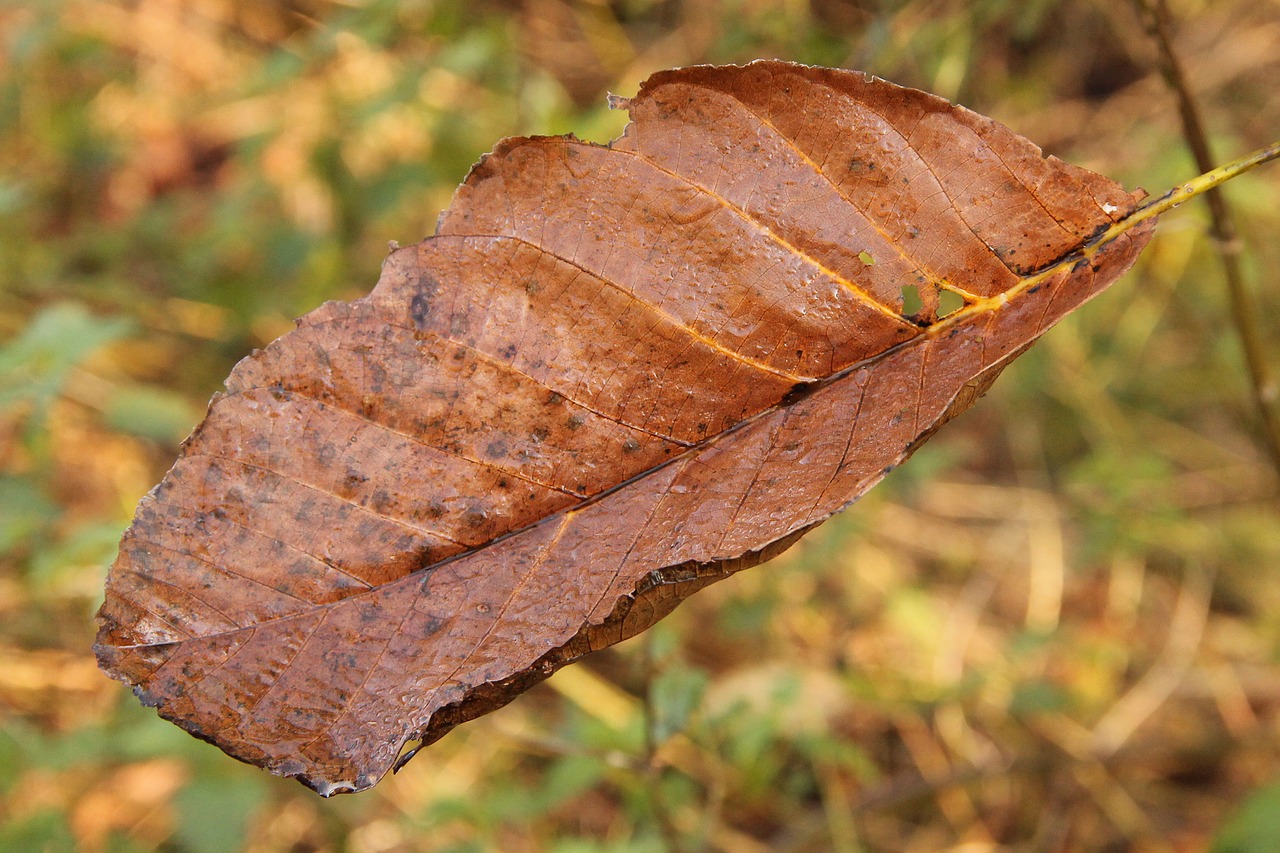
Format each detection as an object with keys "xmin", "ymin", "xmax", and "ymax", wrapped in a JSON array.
[{"xmin": 1137, "ymin": 0, "xmax": 1280, "ymax": 475}]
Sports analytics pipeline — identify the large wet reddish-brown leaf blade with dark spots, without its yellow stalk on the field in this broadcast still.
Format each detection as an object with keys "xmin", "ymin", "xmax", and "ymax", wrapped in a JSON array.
[{"xmin": 97, "ymin": 61, "xmax": 1151, "ymax": 794}]
